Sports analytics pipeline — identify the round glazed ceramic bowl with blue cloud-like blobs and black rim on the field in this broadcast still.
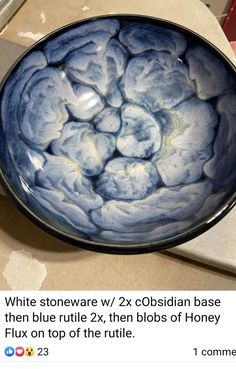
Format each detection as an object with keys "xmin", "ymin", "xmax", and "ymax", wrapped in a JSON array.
[{"xmin": 0, "ymin": 15, "xmax": 236, "ymax": 253}]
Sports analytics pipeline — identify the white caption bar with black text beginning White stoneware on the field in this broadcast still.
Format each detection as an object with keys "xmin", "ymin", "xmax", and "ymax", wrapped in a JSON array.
[{"xmin": 0, "ymin": 291, "xmax": 236, "ymax": 369}]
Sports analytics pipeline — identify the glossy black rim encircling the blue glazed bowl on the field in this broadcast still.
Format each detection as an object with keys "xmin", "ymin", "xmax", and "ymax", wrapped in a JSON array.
[{"xmin": 0, "ymin": 13, "xmax": 236, "ymax": 254}]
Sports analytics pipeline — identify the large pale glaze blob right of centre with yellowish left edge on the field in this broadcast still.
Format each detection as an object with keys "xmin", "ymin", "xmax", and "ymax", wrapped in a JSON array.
[{"xmin": 152, "ymin": 97, "xmax": 217, "ymax": 186}]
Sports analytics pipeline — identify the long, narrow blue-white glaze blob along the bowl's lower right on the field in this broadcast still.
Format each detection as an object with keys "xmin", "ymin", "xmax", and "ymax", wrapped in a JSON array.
[{"xmin": 91, "ymin": 181, "xmax": 212, "ymax": 233}]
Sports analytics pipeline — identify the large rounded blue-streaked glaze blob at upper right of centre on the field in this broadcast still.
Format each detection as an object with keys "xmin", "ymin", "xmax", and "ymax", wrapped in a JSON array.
[{"xmin": 120, "ymin": 51, "xmax": 194, "ymax": 112}]
